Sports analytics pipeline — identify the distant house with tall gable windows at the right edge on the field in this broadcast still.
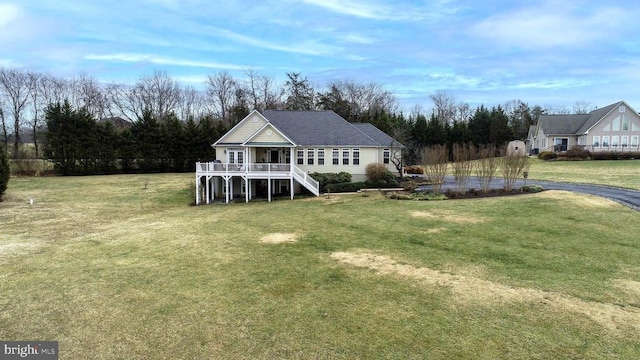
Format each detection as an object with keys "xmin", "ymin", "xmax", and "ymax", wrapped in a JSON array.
[{"xmin": 527, "ymin": 101, "xmax": 640, "ymax": 154}]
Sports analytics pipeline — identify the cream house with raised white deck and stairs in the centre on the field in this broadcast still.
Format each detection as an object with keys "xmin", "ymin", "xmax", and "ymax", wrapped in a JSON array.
[{"xmin": 196, "ymin": 110, "xmax": 404, "ymax": 204}]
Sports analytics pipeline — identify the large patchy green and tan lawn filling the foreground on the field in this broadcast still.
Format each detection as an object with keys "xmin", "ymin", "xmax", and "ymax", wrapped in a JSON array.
[{"xmin": 0, "ymin": 168, "xmax": 640, "ymax": 359}]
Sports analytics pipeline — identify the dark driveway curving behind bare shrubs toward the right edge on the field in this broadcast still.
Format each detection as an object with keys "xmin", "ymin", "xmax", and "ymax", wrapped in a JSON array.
[{"xmin": 420, "ymin": 176, "xmax": 640, "ymax": 211}]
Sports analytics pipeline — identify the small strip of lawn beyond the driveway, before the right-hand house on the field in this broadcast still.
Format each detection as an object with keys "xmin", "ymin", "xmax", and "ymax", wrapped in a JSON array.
[{"xmin": 529, "ymin": 159, "xmax": 640, "ymax": 190}]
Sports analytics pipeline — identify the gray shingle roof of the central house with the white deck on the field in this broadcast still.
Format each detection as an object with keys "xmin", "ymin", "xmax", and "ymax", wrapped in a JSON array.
[{"xmin": 262, "ymin": 110, "xmax": 400, "ymax": 147}]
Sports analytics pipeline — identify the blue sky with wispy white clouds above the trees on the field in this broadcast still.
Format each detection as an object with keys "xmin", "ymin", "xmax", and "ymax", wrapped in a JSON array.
[{"xmin": 0, "ymin": 0, "xmax": 640, "ymax": 109}]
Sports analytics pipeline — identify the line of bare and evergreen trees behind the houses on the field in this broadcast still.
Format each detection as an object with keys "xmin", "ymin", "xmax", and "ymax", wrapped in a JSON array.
[{"xmin": 0, "ymin": 68, "xmax": 593, "ymax": 173}]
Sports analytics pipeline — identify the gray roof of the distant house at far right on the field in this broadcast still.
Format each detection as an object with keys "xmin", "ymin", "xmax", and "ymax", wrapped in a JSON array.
[{"xmin": 538, "ymin": 101, "xmax": 622, "ymax": 135}]
